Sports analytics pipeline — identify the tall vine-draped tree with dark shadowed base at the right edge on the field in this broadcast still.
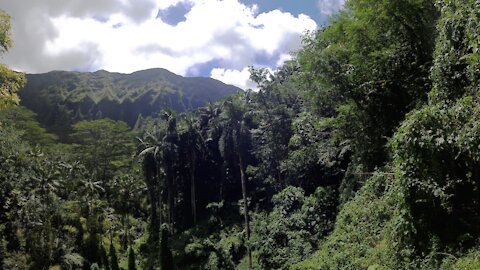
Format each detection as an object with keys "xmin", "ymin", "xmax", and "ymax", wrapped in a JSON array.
[{"xmin": 392, "ymin": 0, "xmax": 480, "ymax": 254}]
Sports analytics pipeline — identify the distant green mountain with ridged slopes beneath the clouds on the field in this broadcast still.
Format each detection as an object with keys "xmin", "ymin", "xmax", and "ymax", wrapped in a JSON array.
[{"xmin": 20, "ymin": 69, "xmax": 240, "ymax": 134}]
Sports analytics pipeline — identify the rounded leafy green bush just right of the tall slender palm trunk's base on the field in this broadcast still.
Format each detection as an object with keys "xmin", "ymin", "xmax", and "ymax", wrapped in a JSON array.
[{"xmin": 252, "ymin": 186, "xmax": 337, "ymax": 269}]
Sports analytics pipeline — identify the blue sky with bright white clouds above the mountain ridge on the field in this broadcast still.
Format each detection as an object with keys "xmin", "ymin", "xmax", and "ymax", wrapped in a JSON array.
[{"xmin": 0, "ymin": 0, "xmax": 344, "ymax": 89}]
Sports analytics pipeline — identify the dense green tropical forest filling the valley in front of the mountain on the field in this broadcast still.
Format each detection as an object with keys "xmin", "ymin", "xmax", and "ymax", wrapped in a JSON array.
[{"xmin": 0, "ymin": 0, "xmax": 480, "ymax": 270}]
